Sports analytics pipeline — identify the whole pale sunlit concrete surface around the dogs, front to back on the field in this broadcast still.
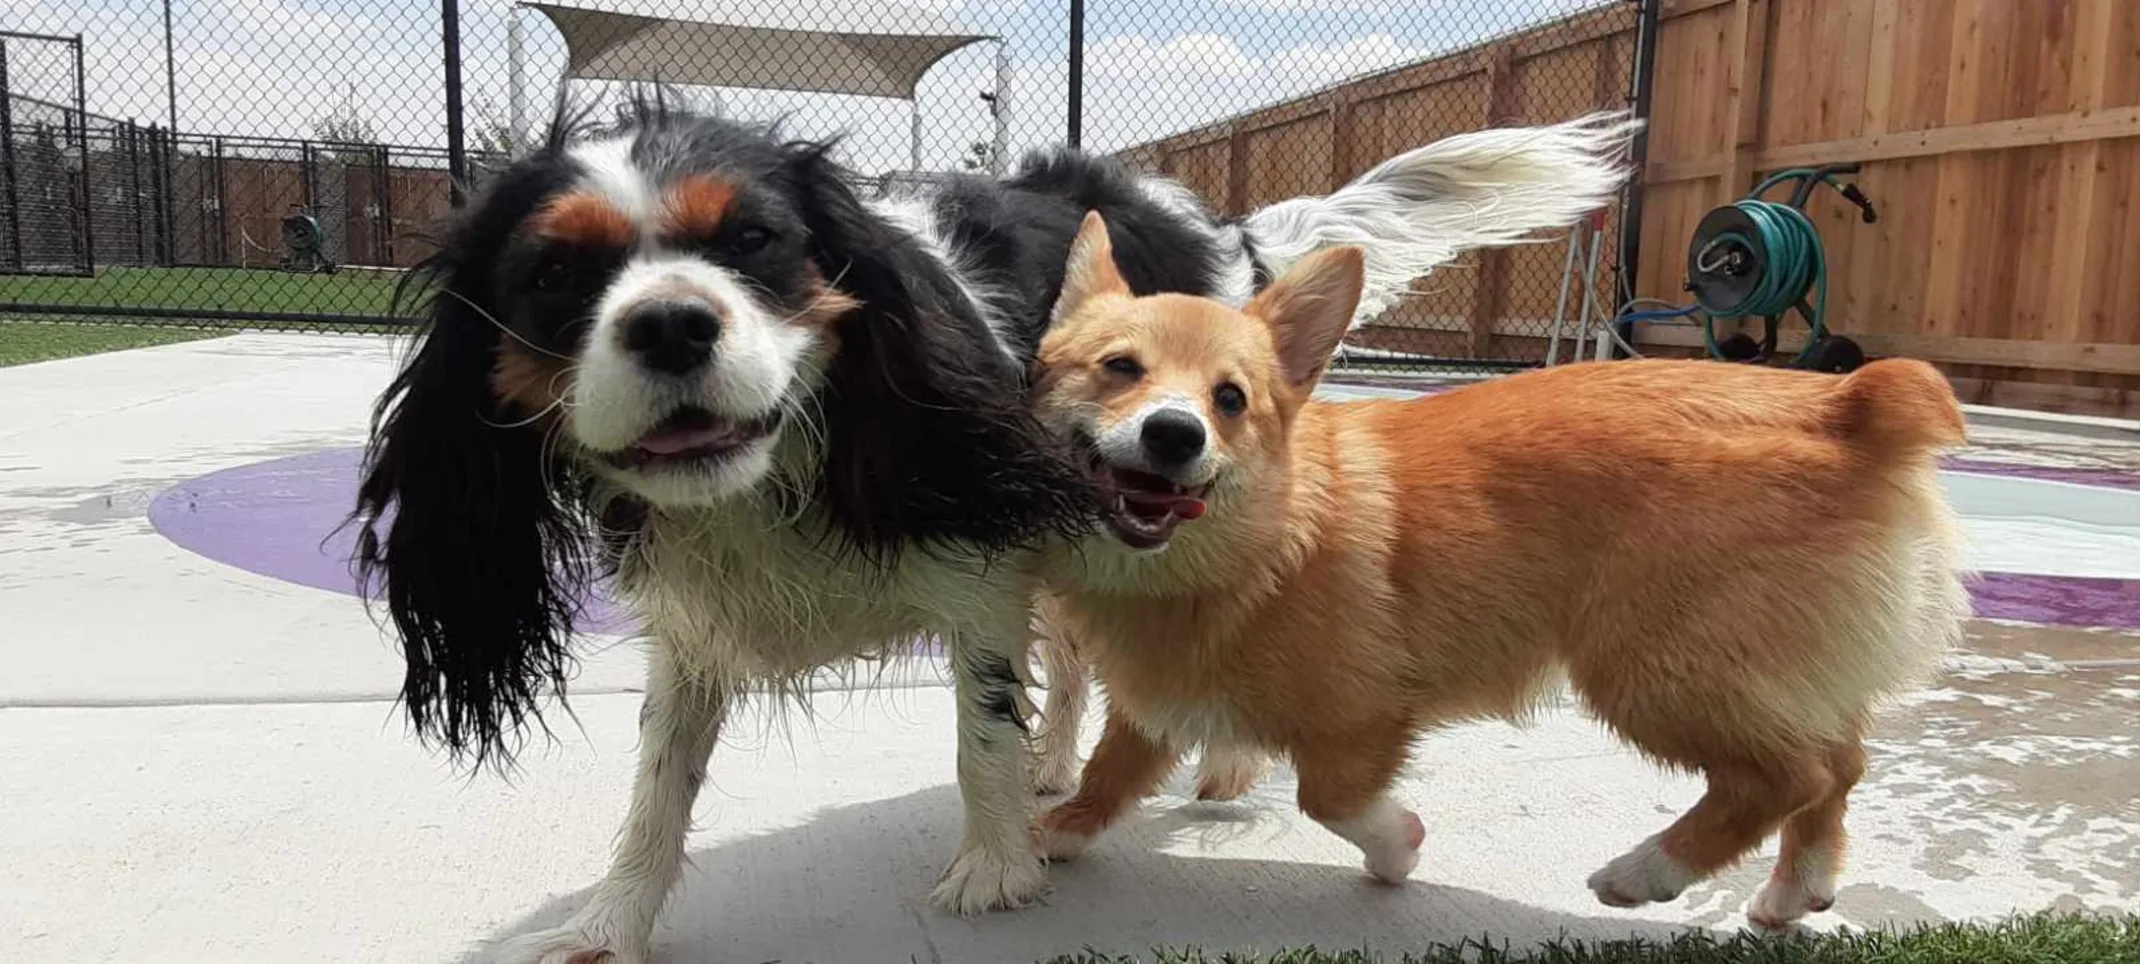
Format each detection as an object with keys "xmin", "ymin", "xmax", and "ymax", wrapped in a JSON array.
[{"xmin": 0, "ymin": 336, "xmax": 2140, "ymax": 964}]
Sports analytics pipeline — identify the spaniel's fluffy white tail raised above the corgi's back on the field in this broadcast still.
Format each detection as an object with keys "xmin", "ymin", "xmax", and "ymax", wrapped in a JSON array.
[{"xmin": 1241, "ymin": 111, "xmax": 1641, "ymax": 328}]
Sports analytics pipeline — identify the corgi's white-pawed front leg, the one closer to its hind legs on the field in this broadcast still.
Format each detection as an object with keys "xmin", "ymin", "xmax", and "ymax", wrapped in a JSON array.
[{"xmin": 1293, "ymin": 730, "xmax": 1427, "ymax": 885}]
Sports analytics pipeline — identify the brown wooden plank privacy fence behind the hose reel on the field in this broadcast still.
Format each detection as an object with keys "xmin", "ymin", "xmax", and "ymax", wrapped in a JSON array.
[{"xmin": 1128, "ymin": 0, "xmax": 2140, "ymax": 416}]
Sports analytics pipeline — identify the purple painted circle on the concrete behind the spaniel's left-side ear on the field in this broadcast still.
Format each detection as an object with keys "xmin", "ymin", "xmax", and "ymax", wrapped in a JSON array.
[{"xmin": 148, "ymin": 448, "xmax": 631, "ymax": 632}]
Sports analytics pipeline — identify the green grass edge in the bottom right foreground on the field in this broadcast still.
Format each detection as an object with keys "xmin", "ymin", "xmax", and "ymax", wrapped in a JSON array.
[{"xmin": 1046, "ymin": 915, "xmax": 2140, "ymax": 964}]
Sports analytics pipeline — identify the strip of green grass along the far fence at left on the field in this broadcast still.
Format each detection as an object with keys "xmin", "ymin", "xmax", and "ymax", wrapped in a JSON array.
[{"xmin": 0, "ymin": 268, "xmax": 400, "ymax": 315}]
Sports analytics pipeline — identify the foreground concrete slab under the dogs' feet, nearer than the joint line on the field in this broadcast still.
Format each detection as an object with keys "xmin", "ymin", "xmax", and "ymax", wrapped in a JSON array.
[{"xmin": 12, "ymin": 675, "xmax": 2140, "ymax": 962}]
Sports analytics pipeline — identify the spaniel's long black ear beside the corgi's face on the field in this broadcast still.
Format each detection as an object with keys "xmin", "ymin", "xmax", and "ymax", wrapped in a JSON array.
[{"xmin": 785, "ymin": 144, "xmax": 1094, "ymax": 561}]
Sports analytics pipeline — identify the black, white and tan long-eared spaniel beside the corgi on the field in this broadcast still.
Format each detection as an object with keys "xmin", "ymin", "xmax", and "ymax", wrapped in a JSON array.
[{"xmin": 357, "ymin": 103, "xmax": 1631, "ymax": 964}]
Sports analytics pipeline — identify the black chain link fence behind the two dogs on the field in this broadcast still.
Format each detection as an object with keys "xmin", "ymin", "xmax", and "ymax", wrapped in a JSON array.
[{"xmin": 0, "ymin": 0, "xmax": 1639, "ymax": 366}]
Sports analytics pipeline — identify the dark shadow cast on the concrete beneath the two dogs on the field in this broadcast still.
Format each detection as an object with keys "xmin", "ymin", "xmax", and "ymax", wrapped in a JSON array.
[{"xmin": 462, "ymin": 784, "xmax": 1684, "ymax": 964}]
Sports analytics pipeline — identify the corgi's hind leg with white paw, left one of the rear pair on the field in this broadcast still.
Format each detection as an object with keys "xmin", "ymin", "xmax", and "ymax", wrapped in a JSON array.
[{"xmin": 1590, "ymin": 752, "xmax": 1834, "ymax": 906}]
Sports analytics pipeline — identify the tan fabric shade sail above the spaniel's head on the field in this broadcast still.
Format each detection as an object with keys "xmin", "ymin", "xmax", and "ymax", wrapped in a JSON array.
[{"xmin": 524, "ymin": 0, "xmax": 995, "ymax": 101}]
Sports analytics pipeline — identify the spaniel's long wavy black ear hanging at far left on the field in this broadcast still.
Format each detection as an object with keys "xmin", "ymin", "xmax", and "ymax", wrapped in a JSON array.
[{"xmin": 353, "ymin": 221, "xmax": 589, "ymax": 765}]
